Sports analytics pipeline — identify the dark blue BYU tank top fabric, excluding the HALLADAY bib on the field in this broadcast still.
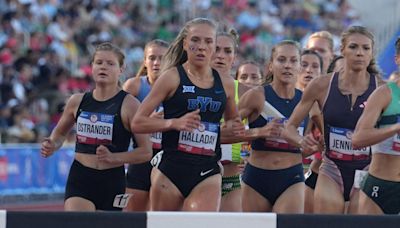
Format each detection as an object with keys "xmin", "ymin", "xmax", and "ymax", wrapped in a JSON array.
[{"xmin": 162, "ymin": 65, "xmax": 226, "ymax": 164}]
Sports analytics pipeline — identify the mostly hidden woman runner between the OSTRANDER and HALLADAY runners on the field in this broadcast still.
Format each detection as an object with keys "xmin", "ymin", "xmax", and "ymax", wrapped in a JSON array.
[{"xmin": 123, "ymin": 40, "xmax": 168, "ymax": 211}]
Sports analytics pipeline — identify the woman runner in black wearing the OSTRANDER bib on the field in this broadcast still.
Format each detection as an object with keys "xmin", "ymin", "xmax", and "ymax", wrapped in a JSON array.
[{"xmin": 41, "ymin": 43, "xmax": 151, "ymax": 211}]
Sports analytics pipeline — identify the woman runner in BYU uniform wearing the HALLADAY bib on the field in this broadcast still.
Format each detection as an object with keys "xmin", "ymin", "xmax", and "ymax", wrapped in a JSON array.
[{"xmin": 134, "ymin": 18, "xmax": 244, "ymax": 211}]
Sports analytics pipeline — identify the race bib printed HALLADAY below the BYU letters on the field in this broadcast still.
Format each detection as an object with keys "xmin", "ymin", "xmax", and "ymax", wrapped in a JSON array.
[{"xmin": 178, "ymin": 122, "xmax": 219, "ymax": 156}]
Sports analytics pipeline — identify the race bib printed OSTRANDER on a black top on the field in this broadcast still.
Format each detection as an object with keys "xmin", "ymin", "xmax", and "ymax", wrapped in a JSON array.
[{"xmin": 76, "ymin": 112, "xmax": 114, "ymax": 145}]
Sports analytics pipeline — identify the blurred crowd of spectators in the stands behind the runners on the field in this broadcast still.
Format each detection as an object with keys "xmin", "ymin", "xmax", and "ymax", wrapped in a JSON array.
[{"xmin": 0, "ymin": 0, "xmax": 360, "ymax": 142}]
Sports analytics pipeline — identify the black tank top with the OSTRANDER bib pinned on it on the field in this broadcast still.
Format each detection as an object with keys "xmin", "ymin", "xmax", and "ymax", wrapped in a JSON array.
[{"xmin": 75, "ymin": 90, "xmax": 132, "ymax": 154}]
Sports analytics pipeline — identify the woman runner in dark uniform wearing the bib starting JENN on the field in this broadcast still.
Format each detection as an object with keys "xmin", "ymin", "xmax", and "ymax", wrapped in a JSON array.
[{"xmin": 285, "ymin": 26, "xmax": 379, "ymax": 213}]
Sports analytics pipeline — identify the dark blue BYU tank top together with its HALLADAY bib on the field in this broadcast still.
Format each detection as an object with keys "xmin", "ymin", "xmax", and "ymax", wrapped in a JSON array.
[{"xmin": 162, "ymin": 65, "xmax": 226, "ymax": 164}]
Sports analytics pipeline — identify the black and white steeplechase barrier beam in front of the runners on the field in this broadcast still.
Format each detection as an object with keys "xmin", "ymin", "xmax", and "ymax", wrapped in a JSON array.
[{"xmin": 0, "ymin": 210, "xmax": 400, "ymax": 228}]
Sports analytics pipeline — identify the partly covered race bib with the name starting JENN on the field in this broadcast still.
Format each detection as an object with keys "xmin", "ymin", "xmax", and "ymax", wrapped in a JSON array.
[{"xmin": 329, "ymin": 127, "xmax": 370, "ymax": 155}]
